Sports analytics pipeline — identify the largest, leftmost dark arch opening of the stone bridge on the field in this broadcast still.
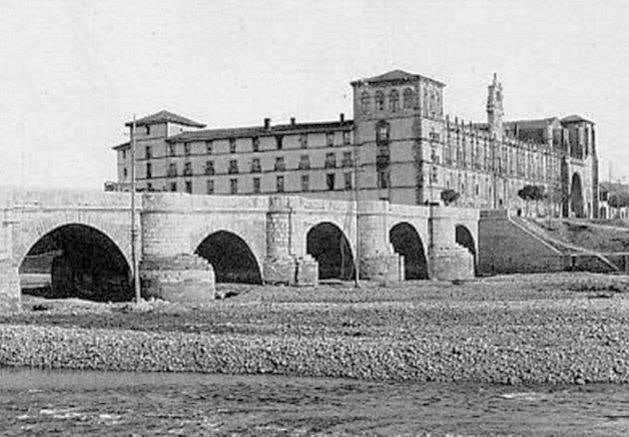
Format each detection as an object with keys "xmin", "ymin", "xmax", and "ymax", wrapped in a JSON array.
[{"xmin": 18, "ymin": 224, "xmax": 133, "ymax": 302}]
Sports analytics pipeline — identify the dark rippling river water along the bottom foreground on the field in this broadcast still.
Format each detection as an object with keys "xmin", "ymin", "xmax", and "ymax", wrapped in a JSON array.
[{"xmin": 0, "ymin": 369, "xmax": 629, "ymax": 436}]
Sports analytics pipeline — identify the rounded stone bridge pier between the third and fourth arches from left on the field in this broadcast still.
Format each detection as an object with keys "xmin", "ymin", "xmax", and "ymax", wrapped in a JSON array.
[{"xmin": 358, "ymin": 202, "xmax": 404, "ymax": 283}]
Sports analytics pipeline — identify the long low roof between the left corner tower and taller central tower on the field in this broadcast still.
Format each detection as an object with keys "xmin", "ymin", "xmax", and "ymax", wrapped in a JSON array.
[{"xmin": 166, "ymin": 120, "xmax": 354, "ymax": 143}]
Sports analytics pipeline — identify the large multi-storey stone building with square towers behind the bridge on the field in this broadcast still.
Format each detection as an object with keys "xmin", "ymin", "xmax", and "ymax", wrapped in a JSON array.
[{"xmin": 110, "ymin": 70, "xmax": 598, "ymax": 217}]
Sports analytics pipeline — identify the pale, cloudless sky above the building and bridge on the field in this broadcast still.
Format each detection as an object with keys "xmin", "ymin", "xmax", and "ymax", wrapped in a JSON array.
[{"xmin": 0, "ymin": 0, "xmax": 629, "ymax": 188}]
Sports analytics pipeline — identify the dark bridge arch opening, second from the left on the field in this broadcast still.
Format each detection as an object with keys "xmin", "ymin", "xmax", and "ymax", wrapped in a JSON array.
[{"xmin": 194, "ymin": 231, "xmax": 262, "ymax": 284}]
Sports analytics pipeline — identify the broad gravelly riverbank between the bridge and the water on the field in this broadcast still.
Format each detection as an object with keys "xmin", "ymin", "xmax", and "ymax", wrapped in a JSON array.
[{"xmin": 0, "ymin": 273, "xmax": 629, "ymax": 384}]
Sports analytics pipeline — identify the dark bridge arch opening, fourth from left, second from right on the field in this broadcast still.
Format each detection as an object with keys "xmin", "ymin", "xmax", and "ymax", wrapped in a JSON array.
[{"xmin": 389, "ymin": 222, "xmax": 428, "ymax": 280}]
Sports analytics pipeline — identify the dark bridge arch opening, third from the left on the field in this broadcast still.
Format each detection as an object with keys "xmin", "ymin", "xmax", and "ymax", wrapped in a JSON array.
[{"xmin": 306, "ymin": 222, "xmax": 355, "ymax": 280}]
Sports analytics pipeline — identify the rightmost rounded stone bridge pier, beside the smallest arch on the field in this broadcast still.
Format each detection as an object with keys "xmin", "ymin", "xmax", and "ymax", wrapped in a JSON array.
[{"xmin": 428, "ymin": 206, "xmax": 474, "ymax": 281}]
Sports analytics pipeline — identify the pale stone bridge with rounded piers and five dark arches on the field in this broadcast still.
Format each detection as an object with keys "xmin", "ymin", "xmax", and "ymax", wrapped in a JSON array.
[{"xmin": 0, "ymin": 189, "xmax": 479, "ymax": 305}]
